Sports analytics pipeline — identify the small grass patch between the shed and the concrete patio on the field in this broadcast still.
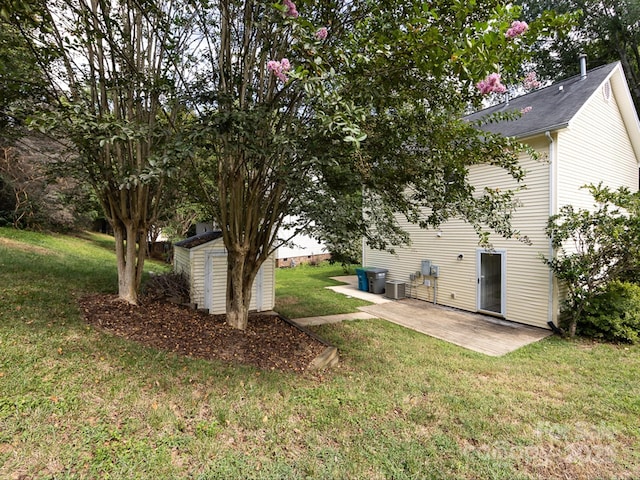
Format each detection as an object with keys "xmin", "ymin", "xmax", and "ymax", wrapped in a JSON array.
[{"xmin": 275, "ymin": 262, "xmax": 370, "ymax": 318}]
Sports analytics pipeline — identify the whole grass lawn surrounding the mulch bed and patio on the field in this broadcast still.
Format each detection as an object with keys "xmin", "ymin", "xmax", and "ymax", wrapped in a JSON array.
[{"xmin": 0, "ymin": 229, "xmax": 640, "ymax": 480}]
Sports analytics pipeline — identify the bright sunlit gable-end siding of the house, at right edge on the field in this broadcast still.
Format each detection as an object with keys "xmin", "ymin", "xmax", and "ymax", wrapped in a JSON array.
[{"xmin": 557, "ymin": 81, "xmax": 638, "ymax": 212}]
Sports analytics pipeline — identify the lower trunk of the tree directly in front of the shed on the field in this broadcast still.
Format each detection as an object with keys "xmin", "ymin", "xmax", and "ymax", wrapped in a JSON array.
[{"xmin": 227, "ymin": 250, "xmax": 259, "ymax": 330}]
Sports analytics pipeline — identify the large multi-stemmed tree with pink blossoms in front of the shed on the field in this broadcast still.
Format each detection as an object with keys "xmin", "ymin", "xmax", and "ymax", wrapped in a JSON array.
[{"xmin": 185, "ymin": 0, "xmax": 568, "ymax": 329}]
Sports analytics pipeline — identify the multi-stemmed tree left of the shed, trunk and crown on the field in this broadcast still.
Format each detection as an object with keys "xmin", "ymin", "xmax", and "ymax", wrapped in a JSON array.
[{"xmin": 2, "ymin": 0, "xmax": 195, "ymax": 304}]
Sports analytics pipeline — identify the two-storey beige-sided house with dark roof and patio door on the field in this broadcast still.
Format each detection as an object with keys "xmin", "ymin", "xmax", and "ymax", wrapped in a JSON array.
[{"xmin": 363, "ymin": 60, "xmax": 640, "ymax": 328}]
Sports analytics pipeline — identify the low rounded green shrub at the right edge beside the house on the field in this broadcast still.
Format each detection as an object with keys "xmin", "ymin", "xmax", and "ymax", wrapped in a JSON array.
[{"xmin": 578, "ymin": 281, "xmax": 640, "ymax": 343}]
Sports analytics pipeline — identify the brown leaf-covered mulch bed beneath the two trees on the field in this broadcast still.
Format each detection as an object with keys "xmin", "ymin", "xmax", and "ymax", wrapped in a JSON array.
[{"xmin": 79, "ymin": 295, "xmax": 327, "ymax": 372}]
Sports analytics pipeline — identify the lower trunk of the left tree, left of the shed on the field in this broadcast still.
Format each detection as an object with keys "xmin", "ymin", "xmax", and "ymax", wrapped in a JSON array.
[{"xmin": 112, "ymin": 222, "xmax": 145, "ymax": 305}]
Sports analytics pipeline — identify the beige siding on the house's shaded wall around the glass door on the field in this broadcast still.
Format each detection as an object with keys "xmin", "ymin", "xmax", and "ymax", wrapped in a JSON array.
[{"xmin": 364, "ymin": 142, "xmax": 549, "ymax": 327}]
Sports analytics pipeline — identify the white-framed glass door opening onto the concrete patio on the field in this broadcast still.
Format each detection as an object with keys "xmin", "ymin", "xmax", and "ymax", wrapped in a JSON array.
[{"xmin": 477, "ymin": 250, "xmax": 507, "ymax": 317}]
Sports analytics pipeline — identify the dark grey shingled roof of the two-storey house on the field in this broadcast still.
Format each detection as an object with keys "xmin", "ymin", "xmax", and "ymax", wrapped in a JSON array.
[{"xmin": 465, "ymin": 62, "xmax": 618, "ymax": 138}]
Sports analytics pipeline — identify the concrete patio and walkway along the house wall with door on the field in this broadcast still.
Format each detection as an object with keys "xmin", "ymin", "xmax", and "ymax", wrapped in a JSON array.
[{"xmin": 294, "ymin": 275, "xmax": 552, "ymax": 356}]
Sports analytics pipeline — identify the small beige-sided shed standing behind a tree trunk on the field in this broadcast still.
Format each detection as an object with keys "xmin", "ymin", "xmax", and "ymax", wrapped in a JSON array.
[{"xmin": 173, "ymin": 230, "xmax": 276, "ymax": 315}]
